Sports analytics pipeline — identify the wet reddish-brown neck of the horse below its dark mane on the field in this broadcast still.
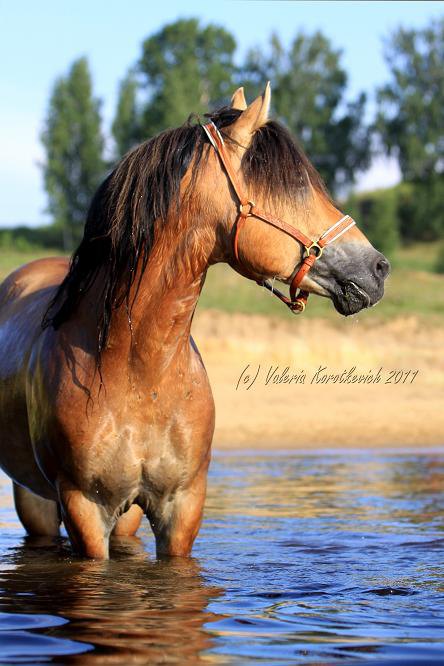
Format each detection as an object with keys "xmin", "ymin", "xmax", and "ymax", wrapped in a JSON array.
[{"xmin": 104, "ymin": 215, "xmax": 214, "ymax": 375}]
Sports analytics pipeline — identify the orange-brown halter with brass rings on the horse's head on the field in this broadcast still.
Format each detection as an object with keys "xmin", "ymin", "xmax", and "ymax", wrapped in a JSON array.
[{"xmin": 202, "ymin": 121, "xmax": 356, "ymax": 314}]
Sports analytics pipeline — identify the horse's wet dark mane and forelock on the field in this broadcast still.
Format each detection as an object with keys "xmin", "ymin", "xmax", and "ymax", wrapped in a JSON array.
[{"xmin": 42, "ymin": 107, "xmax": 328, "ymax": 356}]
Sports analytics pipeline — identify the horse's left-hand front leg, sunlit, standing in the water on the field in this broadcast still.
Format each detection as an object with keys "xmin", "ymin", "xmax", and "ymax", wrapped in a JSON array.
[{"xmin": 58, "ymin": 483, "xmax": 114, "ymax": 560}]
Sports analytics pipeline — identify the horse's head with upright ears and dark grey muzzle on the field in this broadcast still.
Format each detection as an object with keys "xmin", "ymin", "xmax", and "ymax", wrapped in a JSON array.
[{"xmin": 207, "ymin": 85, "xmax": 390, "ymax": 315}]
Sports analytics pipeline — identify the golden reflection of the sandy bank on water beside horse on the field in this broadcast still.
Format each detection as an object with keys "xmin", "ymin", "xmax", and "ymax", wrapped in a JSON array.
[{"xmin": 207, "ymin": 452, "xmax": 444, "ymax": 529}]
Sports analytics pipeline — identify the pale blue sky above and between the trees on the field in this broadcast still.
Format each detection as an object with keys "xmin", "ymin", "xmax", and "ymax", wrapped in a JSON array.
[{"xmin": 0, "ymin": 0, "xmax": 444, "ymax": 226}]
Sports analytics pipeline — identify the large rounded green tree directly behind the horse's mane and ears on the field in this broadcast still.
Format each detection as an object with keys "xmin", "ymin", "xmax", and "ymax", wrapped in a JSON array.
[{"xmin": 139, "ymin": 19, "xmax": 236, "ymax": 137}]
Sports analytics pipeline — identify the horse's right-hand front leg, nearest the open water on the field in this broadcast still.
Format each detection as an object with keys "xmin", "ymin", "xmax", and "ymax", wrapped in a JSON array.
[{"xmin": 148, "ymin": 470, "xmax": 206, "ymax": 557}]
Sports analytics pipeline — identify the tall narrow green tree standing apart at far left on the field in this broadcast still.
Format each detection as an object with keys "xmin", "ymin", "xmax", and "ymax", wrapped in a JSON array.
[{"xmin": 42, "ymin": 58, "xmax": 104, "ymax": 249}]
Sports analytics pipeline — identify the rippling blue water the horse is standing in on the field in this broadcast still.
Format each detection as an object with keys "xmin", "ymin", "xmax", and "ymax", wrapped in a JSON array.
[{"xmin": 0, "ymin": 451, "xmax": 444, "ymax": 666}]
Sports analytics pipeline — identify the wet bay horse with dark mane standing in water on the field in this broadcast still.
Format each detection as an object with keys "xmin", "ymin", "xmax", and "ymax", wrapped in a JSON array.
[{"xmin": 0, "ymin": 84, "xmax": 389, "ymax": 559}]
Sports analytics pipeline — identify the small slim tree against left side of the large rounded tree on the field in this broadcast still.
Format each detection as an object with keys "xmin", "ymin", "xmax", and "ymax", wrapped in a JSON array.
[{"xmin": 111, "ymin": 72, "xmax": 143, "ymax": 158}]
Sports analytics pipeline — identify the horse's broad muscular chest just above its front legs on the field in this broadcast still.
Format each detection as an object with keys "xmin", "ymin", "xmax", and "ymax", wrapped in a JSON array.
[{"xmin": 43, "ymin": 368, "xmax": 213, "ymax": 506}]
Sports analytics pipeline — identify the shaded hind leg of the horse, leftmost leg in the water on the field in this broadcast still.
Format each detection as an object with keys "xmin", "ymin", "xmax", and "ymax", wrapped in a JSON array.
[{"xmin": 12, "ymin": 481, "xmax": 61, "ymax": 536}]
